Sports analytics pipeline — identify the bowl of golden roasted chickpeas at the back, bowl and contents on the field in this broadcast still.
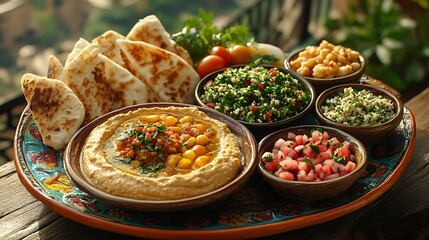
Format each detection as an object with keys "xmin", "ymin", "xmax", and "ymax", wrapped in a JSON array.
[{"xmin": 285, "ymin": 40, "xmax": 365, "ymax": 94}]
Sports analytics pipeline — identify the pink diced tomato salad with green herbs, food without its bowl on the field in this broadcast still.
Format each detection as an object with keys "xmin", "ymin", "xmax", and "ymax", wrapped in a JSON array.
[{"xmin": 261, "ymin": 129, "xmax": 356, "ymax": 182}]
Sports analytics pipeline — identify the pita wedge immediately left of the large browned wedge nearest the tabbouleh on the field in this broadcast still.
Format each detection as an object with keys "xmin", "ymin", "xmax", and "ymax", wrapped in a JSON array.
[{"xmin": 99, "ymin": 54, "xmax": 148, "ymax": 109}]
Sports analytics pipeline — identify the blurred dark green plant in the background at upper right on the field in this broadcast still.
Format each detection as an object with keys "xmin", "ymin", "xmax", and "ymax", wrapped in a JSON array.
[{"xmin": 325, "ymin": 0, "xmax": 429, "ymax": 91}]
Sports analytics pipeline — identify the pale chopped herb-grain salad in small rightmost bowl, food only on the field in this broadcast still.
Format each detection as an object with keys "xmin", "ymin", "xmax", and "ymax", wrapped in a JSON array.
[{"xmin": 321, "ymin": 87, "xmax": 395, "ymax": 126}]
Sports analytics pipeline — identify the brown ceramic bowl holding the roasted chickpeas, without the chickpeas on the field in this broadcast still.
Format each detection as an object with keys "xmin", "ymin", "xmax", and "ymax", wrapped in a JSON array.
[{"xmin": 284, "ymin": 49, "xmax": 365, "ymax": 94}]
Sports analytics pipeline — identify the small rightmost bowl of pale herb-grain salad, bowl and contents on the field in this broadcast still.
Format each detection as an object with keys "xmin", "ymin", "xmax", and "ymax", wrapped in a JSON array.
[{"xmin": 315, "ymin": 83, "xmax": 403, "ymax": 146}]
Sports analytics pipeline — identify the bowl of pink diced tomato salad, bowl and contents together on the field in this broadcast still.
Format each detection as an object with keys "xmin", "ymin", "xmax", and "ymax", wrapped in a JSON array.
[{"xmin": 258, "ymin": 125, "xmax": 367, "ymax": 202}]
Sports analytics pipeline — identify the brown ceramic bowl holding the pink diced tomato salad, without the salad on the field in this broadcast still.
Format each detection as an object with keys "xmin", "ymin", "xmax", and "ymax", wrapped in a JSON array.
[{"xmin": 258, "ymin": 125, "xmax": 367, "ymax": 202}]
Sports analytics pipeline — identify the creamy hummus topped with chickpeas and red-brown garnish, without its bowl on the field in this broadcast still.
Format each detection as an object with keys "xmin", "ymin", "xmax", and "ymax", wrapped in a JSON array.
[{"xmin": 80, "ymin": 107, "xmax": 242, "ymax": 200}]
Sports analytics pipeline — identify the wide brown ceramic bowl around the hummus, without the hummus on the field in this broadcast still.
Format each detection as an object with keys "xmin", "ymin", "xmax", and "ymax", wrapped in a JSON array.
[{"xmin": 64, "ymin": 103, "xmax": 257, "ymax": 212}]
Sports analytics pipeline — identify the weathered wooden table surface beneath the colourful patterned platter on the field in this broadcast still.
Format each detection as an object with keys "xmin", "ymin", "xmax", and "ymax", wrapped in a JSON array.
[{"xmin": 0, "ymin": 88, "xmax": 429, "ymax": 240}]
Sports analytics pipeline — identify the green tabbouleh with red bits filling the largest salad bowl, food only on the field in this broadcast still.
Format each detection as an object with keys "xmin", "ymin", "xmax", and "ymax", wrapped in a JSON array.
[{"xmin": 201, "ymin": 66, "xmax": 311, "ymax": 123}]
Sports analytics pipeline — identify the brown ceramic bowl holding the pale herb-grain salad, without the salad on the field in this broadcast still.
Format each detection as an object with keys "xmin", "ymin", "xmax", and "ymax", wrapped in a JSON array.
[{"xmin": 315, "ymin": 84, "xmax": 403, "ymax": 146}]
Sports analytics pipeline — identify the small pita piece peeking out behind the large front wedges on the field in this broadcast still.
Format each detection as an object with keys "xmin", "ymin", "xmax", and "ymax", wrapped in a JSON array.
[{"xmin": 92, "ymin": 30, "xmax": 126, "ymax": 67}]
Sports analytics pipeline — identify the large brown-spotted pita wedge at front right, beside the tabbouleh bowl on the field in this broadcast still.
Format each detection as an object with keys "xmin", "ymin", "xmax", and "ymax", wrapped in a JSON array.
[{"xmin": 116, "ymin": 39, "xmax": 200, "ymax": 103}]
